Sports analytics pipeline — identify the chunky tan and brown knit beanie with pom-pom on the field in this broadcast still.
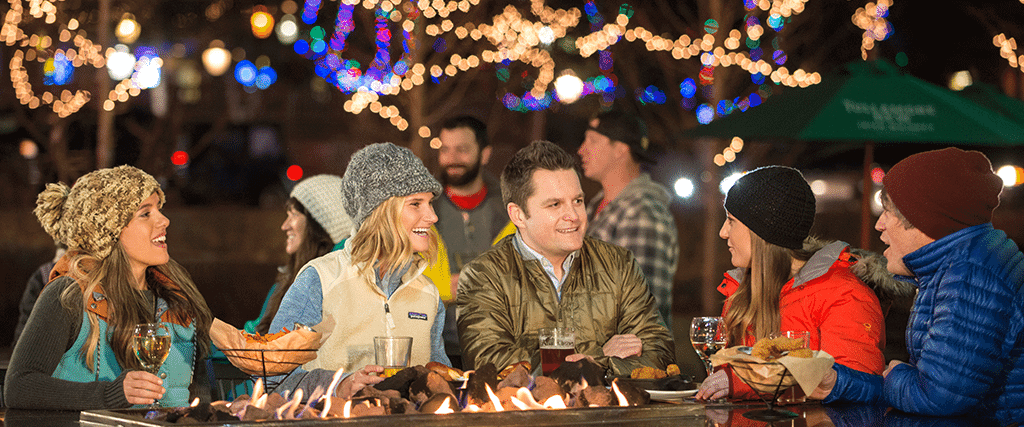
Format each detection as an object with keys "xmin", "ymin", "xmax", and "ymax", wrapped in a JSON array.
[{"xmin": 33, "ymin": 166, "xmax": 164, "ymax": 259}]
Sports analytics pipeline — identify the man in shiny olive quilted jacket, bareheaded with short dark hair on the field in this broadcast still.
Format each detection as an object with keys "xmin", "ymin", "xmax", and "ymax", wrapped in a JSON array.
[{"xmin": 457, "ymin": 141, "xmax": 675, "ymax": 376}]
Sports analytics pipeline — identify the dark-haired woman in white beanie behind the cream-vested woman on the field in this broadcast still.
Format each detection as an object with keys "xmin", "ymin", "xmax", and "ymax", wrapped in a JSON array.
[{"xmin": 245, "ymin": 174, "xmax": 352, "ymax": 334}]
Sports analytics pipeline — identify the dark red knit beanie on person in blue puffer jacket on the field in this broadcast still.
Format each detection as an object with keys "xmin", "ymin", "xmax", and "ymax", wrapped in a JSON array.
[{"xmin": 882, "ymin": 147, "xmax": 1002, "ymax": 240}]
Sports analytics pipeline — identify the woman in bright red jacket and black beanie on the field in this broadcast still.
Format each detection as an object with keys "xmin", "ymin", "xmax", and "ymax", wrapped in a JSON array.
[{"xmin": 696, "ymin": 166, "xmax": 885, "ymax": 399}]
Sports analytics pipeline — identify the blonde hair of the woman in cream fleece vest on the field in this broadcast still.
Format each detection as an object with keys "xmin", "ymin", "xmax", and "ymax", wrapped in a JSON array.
[{"xmin": 346, "ymin": 196, "xmax": 437, "ymax": 273}]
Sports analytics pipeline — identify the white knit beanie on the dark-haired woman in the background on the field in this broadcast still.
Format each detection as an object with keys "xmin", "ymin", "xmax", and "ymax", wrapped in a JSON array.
[{"xmin": 292, "ymin": 174, "xmax": 352, "ymax": 245}]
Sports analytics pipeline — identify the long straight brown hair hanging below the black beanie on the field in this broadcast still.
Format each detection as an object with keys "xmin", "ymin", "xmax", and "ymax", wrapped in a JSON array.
[{"xmin": 725, "ymin": 231, "xmax": 816, "ymax": 345}]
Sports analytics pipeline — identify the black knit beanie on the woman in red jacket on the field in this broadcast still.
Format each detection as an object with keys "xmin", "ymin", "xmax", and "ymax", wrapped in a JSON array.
[{"xmin": 725, "ymin": 166, "xmax": 814, "ymax": 249}]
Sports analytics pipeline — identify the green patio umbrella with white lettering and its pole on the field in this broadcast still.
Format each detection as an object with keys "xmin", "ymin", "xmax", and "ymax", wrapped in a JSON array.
[{"xmin": 682, "ymin": 60, "xmax": 1024, "ymax": 247}]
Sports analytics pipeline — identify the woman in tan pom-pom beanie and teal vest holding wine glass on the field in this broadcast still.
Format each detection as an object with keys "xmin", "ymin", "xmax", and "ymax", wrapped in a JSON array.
[{"xmin": 5, "ymin": 166, "xmax": 212, "ymax": 411}]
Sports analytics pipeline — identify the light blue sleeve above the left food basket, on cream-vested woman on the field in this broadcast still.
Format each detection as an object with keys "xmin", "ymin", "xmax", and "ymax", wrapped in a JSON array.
[{"xmin": 267, "ymin": 267, "xmax": 324, "ymax": 334}]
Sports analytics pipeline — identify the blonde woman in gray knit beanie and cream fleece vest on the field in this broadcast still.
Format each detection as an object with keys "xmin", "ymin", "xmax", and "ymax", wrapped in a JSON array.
[{"xmin": 269, "ymin": 142, "xmax": 451, "ymax": 397}]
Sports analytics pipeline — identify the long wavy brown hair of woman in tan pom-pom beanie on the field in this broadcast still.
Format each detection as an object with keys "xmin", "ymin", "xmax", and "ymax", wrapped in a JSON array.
[{"xmin": 61, "ymin": 242, "xmax": 213, "ymax": 370}]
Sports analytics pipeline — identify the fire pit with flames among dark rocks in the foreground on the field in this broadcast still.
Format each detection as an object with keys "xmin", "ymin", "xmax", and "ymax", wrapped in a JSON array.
[{"xmin": 81, "ymin": 360, "xmax": 703, "ymax": 427}]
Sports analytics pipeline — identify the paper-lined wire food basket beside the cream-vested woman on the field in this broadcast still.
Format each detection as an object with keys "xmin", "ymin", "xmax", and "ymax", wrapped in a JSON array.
[{"xmin": 210, "ymin": 318, "xmax": 321, "ymax": 378}]
